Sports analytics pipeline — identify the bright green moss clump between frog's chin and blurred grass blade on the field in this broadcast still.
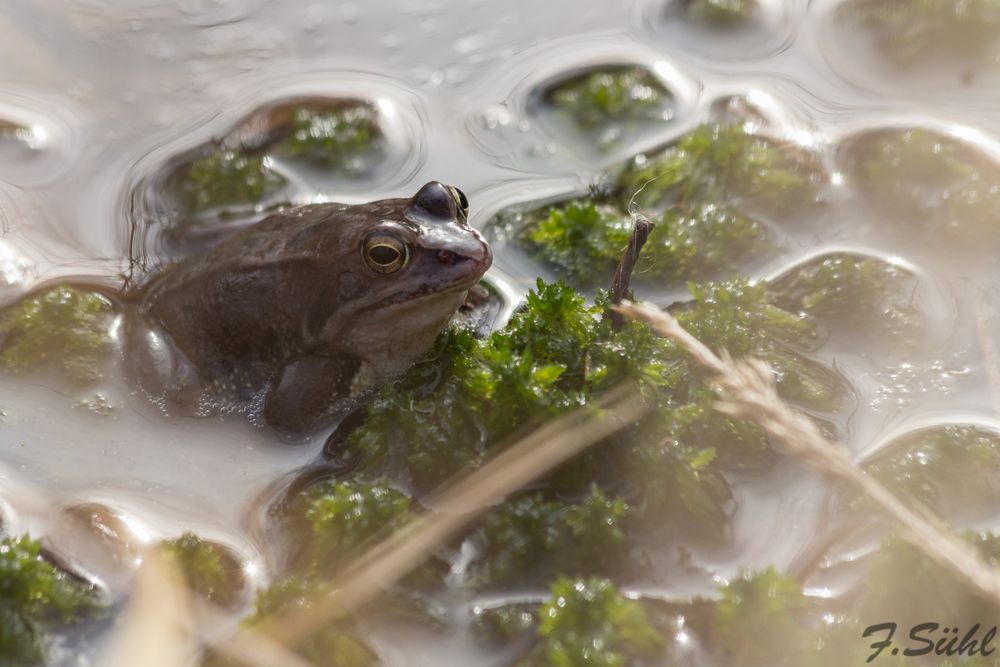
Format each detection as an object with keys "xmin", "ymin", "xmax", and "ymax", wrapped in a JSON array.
[{"xmin": 347, "ymin": 282, "xmax": 672, "ymax": 491}]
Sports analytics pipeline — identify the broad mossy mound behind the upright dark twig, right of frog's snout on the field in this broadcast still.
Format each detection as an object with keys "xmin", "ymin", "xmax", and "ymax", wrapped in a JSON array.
[{"xmin": 508, "ymin": 122, "xmax": 825, "ymax": 289}]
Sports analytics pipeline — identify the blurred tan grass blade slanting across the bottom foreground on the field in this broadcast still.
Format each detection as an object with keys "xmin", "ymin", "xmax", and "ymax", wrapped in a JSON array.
[{"xmin": 216, "ymin": 388, "xmax": 647, "ymax": 667}]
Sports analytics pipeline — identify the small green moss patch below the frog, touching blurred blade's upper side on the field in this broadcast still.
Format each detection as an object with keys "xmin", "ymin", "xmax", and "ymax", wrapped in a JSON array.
[{"xmin": 305, "ymin": 480, "xmax": 410, "ymax": 573}]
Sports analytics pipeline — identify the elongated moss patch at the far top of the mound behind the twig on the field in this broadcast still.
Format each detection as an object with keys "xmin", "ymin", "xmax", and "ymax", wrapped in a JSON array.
[{"xmin": 617, "ymin": 123, "xmax": 825, "ymax": 214}]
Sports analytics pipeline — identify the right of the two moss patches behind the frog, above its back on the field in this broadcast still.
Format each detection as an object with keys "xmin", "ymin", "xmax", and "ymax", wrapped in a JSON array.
[{"xmin": 275, "ymin": 103, "xmax": 383, "ymax": 175}]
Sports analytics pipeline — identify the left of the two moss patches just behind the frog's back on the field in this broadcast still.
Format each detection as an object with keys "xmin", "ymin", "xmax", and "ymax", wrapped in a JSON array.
[{"xmin": 172, "ymin": 150, "xmax": 287, "ymax": 213}]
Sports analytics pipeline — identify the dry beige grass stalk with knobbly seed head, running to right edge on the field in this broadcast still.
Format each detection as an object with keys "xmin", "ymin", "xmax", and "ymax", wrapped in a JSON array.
[{"xmin": 618, "ymin": 304, "xmax": 1000, "ymax": 605}]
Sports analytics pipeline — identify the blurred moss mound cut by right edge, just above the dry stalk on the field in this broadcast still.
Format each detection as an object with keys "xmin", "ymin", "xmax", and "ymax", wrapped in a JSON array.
[{"xmin": 865, "ymin": 425, "xmax": 1000, "ymax": 517}]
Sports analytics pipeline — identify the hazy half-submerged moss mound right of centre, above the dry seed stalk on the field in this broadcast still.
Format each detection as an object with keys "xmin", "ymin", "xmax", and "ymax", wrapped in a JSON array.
[{"xmin": 770, "ymin": 253, "xmax": 919, "ymax": 340}]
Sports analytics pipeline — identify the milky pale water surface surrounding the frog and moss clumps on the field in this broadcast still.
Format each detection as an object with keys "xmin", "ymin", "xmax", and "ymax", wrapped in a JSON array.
[{"xmin": 0, "ymin": 0, "xmax": 1000, "ymax": 664}]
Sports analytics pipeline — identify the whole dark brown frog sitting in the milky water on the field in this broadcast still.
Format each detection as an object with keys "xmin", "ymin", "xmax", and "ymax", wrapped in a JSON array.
[{"xmin": 127, "ymin": 182, "xmax": 492, "ymax": 432}]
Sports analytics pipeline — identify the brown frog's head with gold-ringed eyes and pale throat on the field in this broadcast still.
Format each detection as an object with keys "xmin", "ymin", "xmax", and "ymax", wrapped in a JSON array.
[{"xmin": 324, "ymin": 181, "xmax": 493, "ymax": 368}]
